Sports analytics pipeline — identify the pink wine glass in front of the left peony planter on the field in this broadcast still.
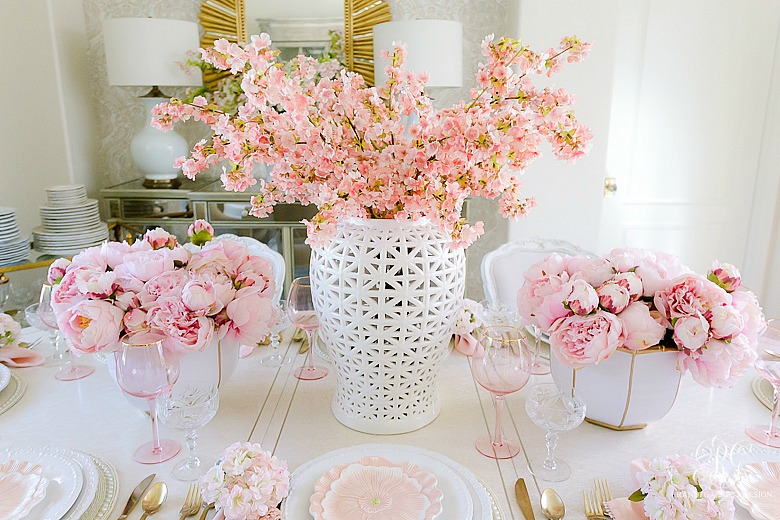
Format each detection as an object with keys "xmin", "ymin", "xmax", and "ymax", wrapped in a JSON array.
[{"xmin": 116, "ymin": 330, "xmax": 181, "ymax": 464}]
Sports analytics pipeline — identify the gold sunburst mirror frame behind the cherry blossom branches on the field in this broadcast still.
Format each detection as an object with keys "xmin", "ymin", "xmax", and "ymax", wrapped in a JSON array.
[{"xmin": 198, "ymin": 0, "xmax": 392, "ymax": 89}]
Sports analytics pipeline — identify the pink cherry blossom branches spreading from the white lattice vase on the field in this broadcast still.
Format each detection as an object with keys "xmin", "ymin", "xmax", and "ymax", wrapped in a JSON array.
[{"xmin": 153, "ymin": 34, "xmax": 592, "ymax": 246}]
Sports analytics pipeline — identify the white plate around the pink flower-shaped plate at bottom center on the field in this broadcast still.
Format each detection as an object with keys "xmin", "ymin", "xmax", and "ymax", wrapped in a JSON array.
[{"xmin": 282, "ymin": 444, "xmax": 493, "ymax": 520}]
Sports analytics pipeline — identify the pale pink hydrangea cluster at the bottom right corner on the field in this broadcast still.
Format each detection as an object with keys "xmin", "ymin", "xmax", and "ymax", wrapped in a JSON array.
[{"xmin": 629, "ymin": 455, "xmax": 734, "ymax": 520}]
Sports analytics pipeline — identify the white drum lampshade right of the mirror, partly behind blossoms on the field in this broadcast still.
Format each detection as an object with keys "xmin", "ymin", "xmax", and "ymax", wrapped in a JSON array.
[{"xmin": 374, "ymin": 20, "xmax": 463, "ymax": 87}]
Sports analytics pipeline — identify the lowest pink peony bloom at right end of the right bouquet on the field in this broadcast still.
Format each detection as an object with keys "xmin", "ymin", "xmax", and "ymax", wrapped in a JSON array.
[{"xmin": 679, "ymin": 334, "xmax": 756, "ymax": 388}]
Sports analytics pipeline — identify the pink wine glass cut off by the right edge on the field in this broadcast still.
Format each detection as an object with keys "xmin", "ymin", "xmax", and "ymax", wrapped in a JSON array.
[{"xmin": 746, "ymin": 319, "xmax": 780, "ymax": 448}]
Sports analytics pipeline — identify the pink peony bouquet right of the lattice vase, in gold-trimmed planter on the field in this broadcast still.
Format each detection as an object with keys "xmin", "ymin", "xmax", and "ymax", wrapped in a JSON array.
[{"xmin": 517, "ymin": 248, "xmax": 766, "ymax": 387}]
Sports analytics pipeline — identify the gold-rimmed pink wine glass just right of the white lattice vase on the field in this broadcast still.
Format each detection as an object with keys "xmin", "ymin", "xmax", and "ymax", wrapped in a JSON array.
[{"xmin": 471, "ymin": 325, "xmax": 531, "ymax": 459}]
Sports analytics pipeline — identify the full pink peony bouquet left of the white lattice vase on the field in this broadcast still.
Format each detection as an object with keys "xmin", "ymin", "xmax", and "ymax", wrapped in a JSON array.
[{"xmin": 49, "ymin": 221, "xmax": 275, "ymax": 354}]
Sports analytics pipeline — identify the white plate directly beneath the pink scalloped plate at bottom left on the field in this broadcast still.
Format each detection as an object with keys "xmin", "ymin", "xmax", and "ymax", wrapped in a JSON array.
[{"xmin": 0, "ymin": 446, "xmax": 84, "ymax": 520}]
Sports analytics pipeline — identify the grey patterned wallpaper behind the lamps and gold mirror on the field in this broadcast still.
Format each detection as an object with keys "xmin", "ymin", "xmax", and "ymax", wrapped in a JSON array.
[{"xmin": 83, "ymin": 0, "xmax": 512, "ymax": 300}]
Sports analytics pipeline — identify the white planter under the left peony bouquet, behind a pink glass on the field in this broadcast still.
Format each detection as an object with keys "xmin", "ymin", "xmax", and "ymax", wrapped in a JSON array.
[{"xmin": 106, "ymin": 335, "xmax": 239, "ymax": 411}]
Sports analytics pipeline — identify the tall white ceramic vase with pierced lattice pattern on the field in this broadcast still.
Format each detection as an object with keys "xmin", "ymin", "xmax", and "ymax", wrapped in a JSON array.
[{"xmin": 310, "ymin": 219, "xmax": 466, "ymax": 434}]
